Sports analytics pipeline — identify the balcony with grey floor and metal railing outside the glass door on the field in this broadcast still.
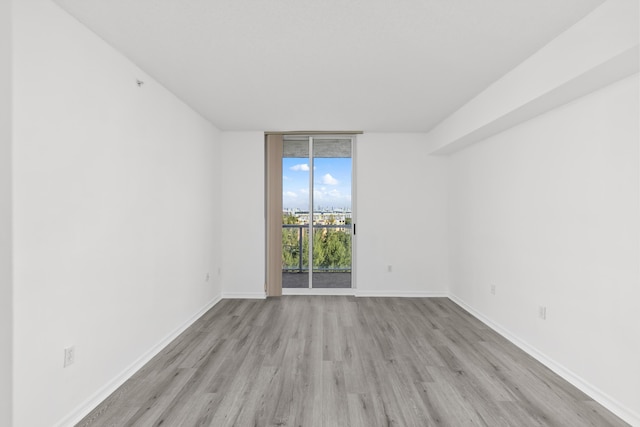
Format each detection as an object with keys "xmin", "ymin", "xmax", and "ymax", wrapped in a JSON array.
[{"xmin": 282, "ymin": 224, "xmax": 351, "ymax": 288}]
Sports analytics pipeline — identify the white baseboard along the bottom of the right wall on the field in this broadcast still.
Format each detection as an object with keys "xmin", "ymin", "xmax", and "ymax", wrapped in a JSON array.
[{"xmin": 449, "ymin": 293, "xmax": 640, "ymax": 426}]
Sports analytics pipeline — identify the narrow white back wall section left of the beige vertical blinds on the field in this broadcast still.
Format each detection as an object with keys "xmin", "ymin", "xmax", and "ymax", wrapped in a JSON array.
[{"xmin": 221, "ymin": 132, "xmax": 265, "ymax": 298}]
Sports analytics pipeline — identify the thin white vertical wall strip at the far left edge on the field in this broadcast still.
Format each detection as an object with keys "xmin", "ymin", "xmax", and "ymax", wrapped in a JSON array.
[{"xmin": 0, "ymin": 1, "xmax": 13, "ymax": 426}]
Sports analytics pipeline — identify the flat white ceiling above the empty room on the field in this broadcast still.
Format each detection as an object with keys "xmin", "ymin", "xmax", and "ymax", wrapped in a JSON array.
[{"xmin": 55, "ymin": 0, "xmax": 603, "ymax": 132}]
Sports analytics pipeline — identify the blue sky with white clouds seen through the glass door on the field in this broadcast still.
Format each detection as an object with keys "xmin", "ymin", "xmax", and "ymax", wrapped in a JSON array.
[{"xmin": 282, "ymin": 158, "xmax": 351, "ymax": 210}]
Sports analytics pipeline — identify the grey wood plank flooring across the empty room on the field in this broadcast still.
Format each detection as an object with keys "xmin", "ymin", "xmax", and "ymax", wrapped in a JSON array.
[{"xmin": 78, "ymin": 296, "xmax": 627, "ymax": 427}]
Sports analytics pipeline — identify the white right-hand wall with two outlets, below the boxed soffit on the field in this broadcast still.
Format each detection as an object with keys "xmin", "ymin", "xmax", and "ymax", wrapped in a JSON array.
[{"xmin": 449, "ymin": 75, "xmax": 640, "ymax": 425}]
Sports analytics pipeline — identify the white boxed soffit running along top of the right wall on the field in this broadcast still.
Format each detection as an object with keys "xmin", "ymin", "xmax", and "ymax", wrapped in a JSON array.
[{"xmin": 426, "ymin": 0, "xmax": 640, "ymax": 154}]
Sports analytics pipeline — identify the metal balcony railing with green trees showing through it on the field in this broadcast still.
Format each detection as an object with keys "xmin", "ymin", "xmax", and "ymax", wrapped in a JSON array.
[{"xmin": 282, "ymin": 224, "xmax": 352, "ymax": 273}]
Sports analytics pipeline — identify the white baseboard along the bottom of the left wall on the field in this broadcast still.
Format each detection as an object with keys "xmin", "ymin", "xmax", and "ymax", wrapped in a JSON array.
[{"xmin": 54, "ymin": 295, "xmax": 222, "ymax": 427}]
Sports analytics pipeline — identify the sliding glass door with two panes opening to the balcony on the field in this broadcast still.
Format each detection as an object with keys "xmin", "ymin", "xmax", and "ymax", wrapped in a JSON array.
[{"xmin": 282, "ymin": 136, "xmax": 353, "ymax": 288}]
